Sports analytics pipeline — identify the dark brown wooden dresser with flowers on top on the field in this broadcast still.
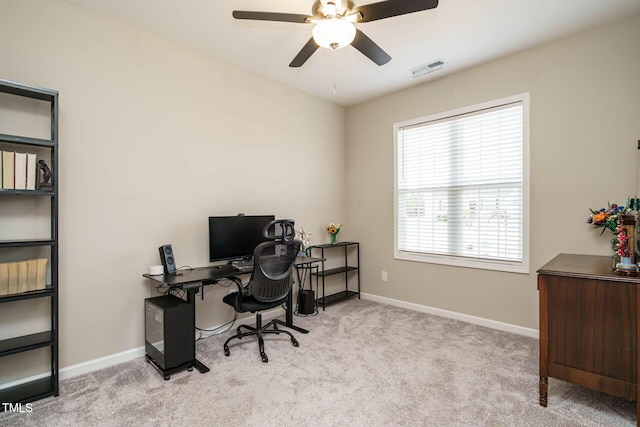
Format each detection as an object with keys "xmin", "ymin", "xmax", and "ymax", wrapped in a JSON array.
[{"xmin": 538, "ymin": 254, "xmax": 640, "ymax": 419}]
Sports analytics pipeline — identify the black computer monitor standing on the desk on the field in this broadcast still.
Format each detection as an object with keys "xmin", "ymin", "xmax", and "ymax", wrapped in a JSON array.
[{"xmin": 209, "ymin": 215, "xmax": 275, "ymax": 262}]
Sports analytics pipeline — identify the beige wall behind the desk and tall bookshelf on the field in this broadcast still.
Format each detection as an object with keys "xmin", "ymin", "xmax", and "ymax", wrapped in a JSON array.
[{"xmin": 0, "ymin": 0, "xmax": 346, "ymax": 383}]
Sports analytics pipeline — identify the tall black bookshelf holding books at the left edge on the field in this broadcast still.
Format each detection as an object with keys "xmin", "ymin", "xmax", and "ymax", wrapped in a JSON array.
[{"xmin": 0, "ymin": 79, "xmax": 59, "ymax": 411}]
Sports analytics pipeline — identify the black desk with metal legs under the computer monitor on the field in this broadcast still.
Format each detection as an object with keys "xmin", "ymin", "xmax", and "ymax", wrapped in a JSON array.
[{"xmin": 142, "ymin": 257, "xmax": 322, "ymax": 376}]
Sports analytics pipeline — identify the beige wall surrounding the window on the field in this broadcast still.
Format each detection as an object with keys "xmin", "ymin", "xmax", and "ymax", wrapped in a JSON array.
[{"xmin": 347, "ymin": 12, "xmax": 640, "ymax": 329}]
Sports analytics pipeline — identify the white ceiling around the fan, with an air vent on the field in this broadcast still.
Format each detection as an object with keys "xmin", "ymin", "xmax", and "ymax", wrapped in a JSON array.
[{"xmin": 67, "ymin": 0, "xmax": 640, "ymax": 106}]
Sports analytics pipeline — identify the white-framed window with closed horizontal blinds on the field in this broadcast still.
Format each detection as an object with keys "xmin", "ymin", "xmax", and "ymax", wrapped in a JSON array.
[{"xmin": 394, "ymin": 94, "xmax": 529, "ymax": 273}]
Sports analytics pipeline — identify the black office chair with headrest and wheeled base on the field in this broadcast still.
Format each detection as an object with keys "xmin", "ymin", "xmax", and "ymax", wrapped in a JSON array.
[{"xmin": 223, "ymin": 220, "xmax": 302, "ymax": 363}]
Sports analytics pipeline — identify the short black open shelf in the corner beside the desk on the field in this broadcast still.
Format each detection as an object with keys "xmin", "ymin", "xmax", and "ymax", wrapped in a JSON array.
[{"xmin": 311, "ymin": 242, "xmax": 360, "ymax": 311}]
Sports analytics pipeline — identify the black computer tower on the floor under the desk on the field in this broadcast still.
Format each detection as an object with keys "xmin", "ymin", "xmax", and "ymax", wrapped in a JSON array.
[{"xmin": 144, "ymin": 295, "xmax": 196, "ymax": 371}]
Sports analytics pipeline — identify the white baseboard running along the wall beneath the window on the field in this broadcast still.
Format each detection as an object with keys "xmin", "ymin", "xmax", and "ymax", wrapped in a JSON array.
[{"xmin": 360, "ymin": 293, "xmax": 540, "ymax": 339}]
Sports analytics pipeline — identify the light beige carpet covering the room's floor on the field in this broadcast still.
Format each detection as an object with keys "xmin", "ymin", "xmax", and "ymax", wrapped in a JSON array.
[{"xmin": 0, "ymin": 300, "xmax": 636, "ymax": 427}]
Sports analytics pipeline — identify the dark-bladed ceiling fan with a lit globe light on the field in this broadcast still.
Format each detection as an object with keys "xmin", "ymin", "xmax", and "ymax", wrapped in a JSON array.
[{"xmin": 233, "ymin": 0, "xmax": 438, "ymax": 67}]
